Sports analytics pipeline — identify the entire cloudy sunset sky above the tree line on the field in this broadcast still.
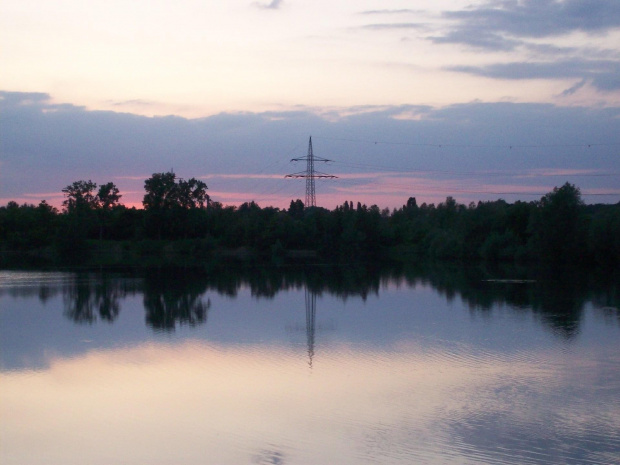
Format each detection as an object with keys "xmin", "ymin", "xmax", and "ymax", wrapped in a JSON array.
[{"xmin": 0, "ymin": 0, "xmax": 620, "ymax": 208}]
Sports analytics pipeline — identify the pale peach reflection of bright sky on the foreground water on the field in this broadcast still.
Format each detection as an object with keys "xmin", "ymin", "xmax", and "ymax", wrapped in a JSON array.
[{"xmin": 1, "ymin": 341, "xmax": 620, "ymax": 465}]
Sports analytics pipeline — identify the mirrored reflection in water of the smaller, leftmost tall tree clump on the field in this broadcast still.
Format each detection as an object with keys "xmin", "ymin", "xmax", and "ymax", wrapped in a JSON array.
[{"xmin": 63, "ymin": 273, "xmax": 133, "ymax": 323}]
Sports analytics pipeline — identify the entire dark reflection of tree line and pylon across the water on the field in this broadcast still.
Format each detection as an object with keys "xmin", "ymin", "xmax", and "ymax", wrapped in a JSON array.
[{"xmin": 0, "ymin": 265, "xmax": 620, "ymax": 336}]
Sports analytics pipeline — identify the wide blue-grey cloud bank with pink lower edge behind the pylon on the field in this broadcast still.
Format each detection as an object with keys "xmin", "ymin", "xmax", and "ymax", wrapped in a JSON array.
[{"xmin": 0, "ymin": 92, "xmax": 620, "ymax": 208}]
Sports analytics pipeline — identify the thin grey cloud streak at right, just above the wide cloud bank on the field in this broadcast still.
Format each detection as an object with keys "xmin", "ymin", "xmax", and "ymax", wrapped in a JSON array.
[{"xmin": 446, "ymin": 59, "xmax": 620, "ymax": 91}]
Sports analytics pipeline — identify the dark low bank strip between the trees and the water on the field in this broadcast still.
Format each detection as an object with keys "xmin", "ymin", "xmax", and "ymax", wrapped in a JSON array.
[{"xmin": 0, "ymin": 239, "xmax": 620, "ymax": 275}]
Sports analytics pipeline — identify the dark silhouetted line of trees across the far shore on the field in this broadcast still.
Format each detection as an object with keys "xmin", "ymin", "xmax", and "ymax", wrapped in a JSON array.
[{"xmin": 0, "ymin": 172, "xmax": 620, "ymax": 268}]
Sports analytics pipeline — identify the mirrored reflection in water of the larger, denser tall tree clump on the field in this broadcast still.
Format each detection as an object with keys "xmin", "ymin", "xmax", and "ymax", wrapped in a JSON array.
[{"xmin": 144, "ymin": 270, "xmax": 211, "ymax": 331}]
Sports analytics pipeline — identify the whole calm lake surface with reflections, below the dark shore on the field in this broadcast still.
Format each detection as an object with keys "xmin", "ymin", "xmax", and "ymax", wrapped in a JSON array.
[{"xmin": 0, "ymin": 267, "xmax": 620, "ymax": 465}]
